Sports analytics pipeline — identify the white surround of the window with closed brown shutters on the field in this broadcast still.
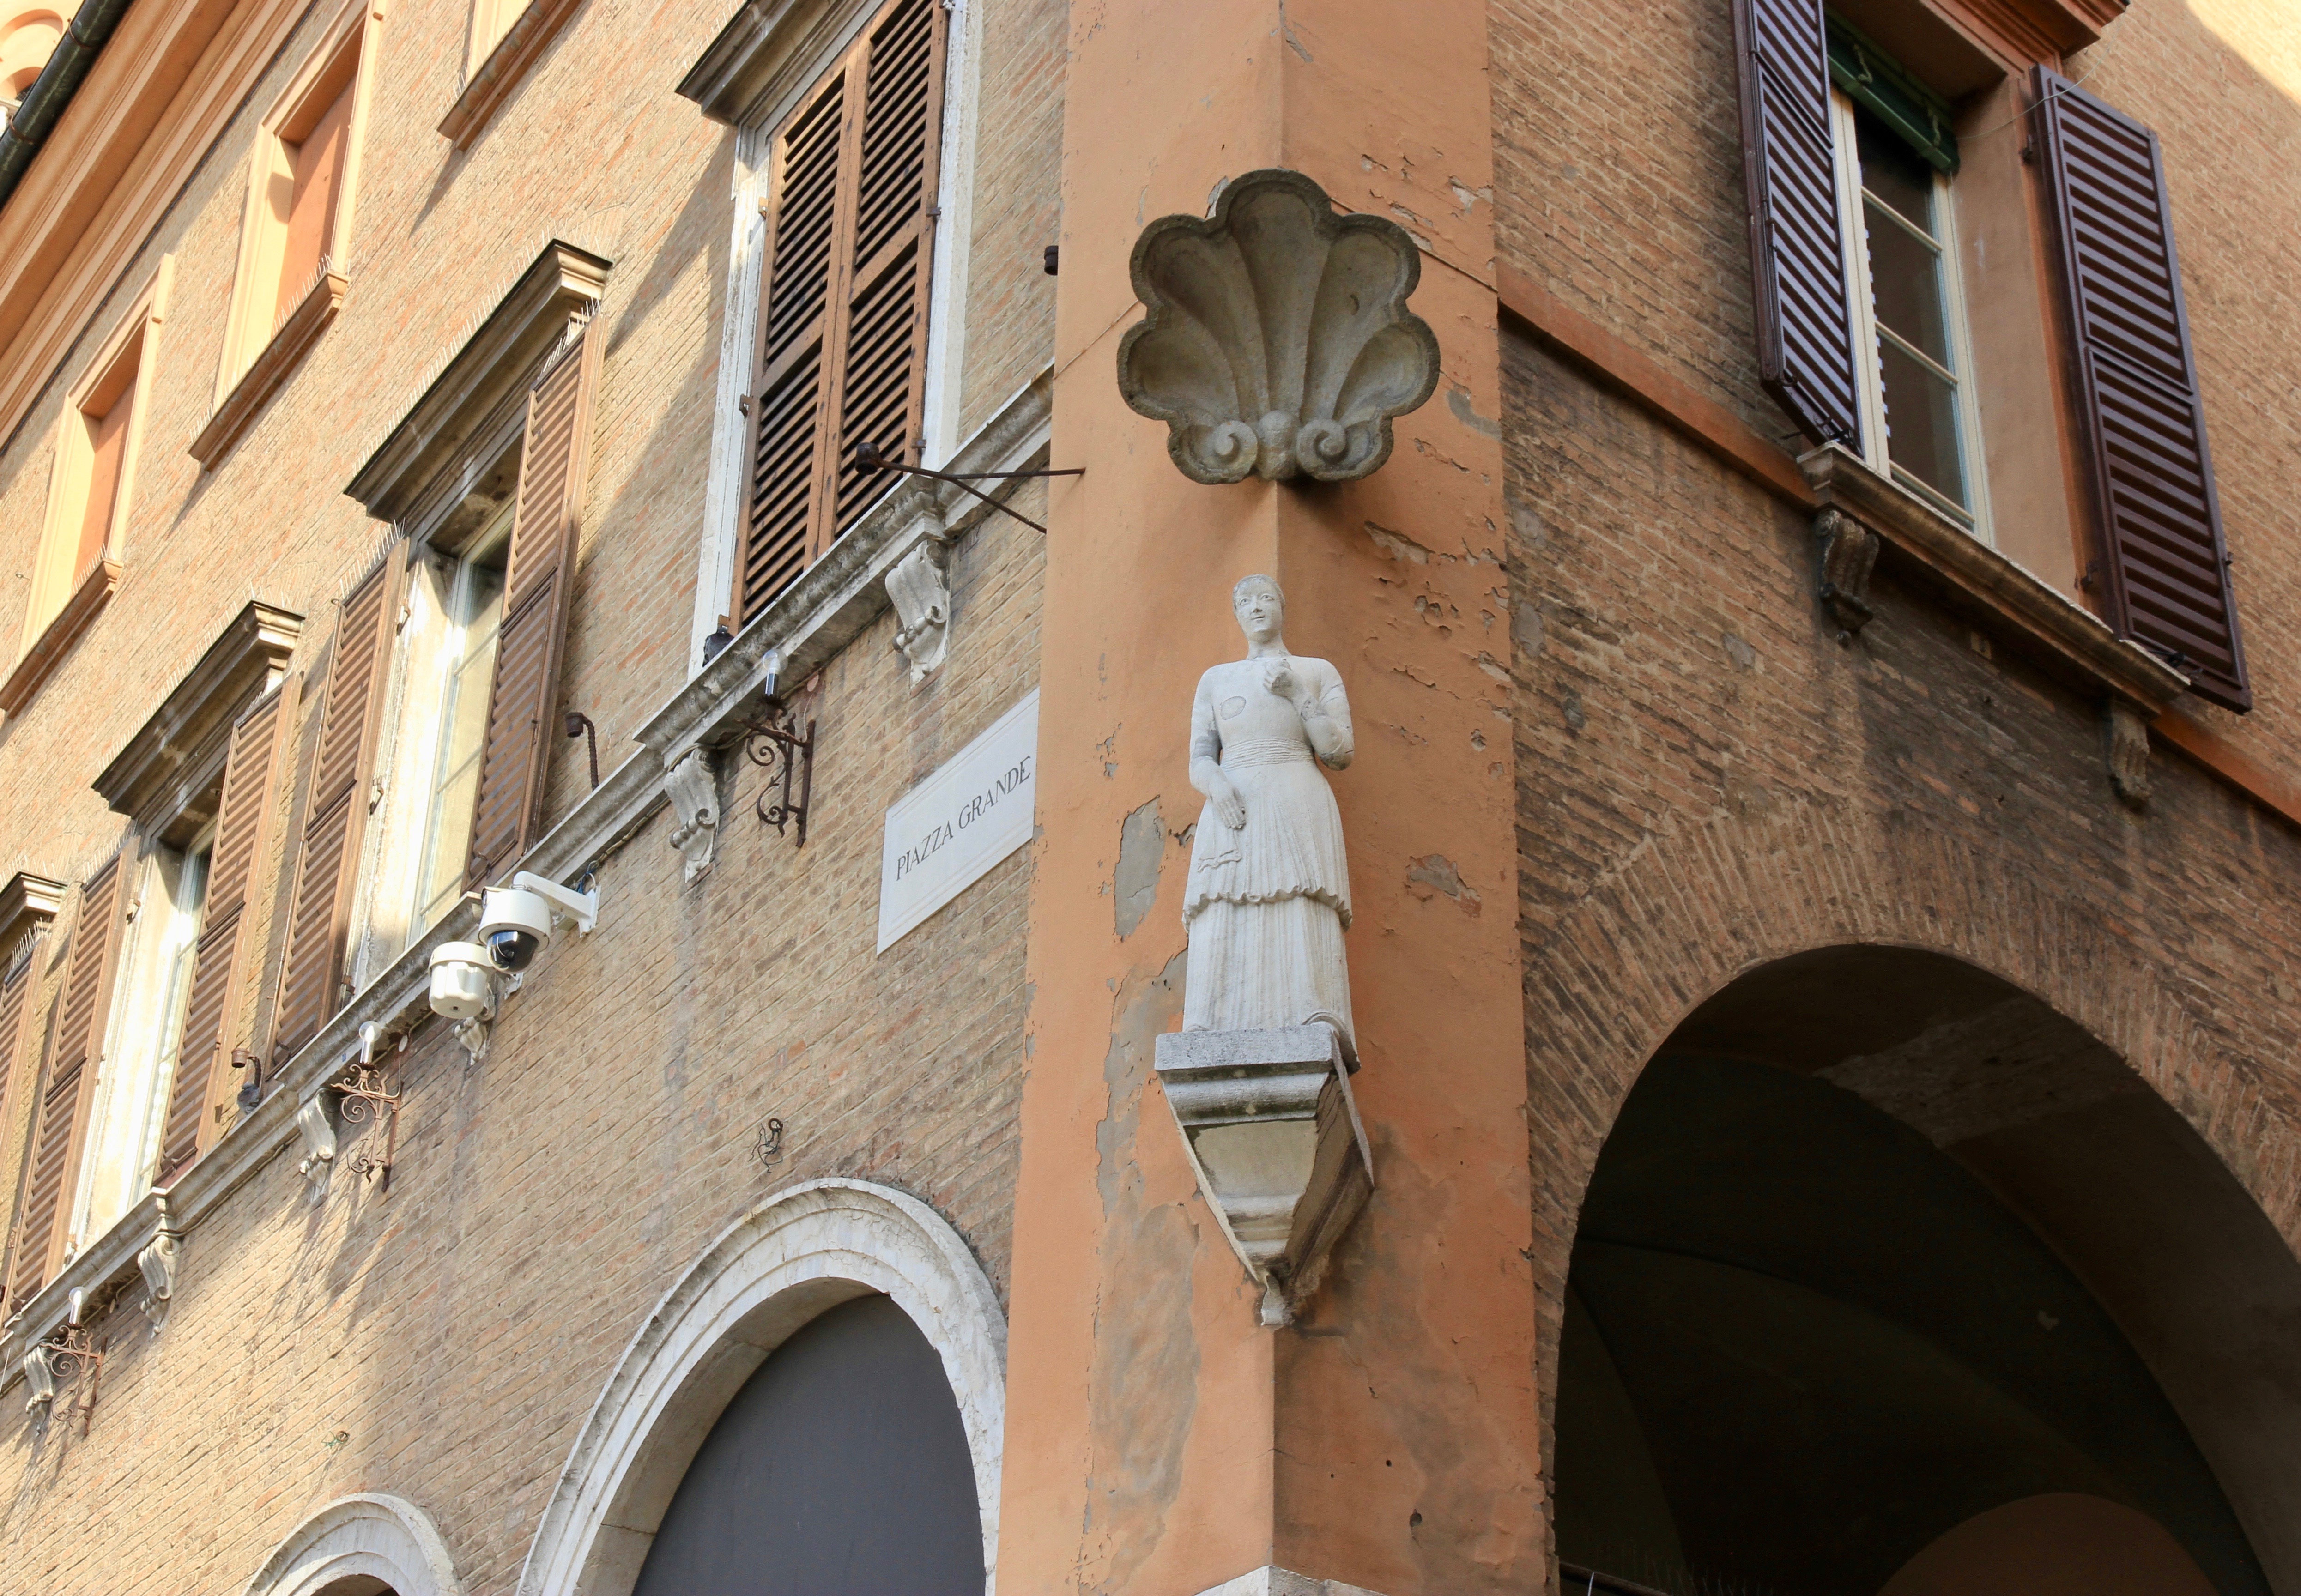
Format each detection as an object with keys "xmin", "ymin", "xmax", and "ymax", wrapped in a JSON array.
[{"xmin": 688, "ymin": 0, "xmax": 982, "ymax": 676}]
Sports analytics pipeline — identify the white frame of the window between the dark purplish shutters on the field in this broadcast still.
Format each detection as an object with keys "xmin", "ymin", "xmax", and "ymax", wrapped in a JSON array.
[{"xmin": 1829, "ymin": 87, "xmax": 1997, "ymax": 547}]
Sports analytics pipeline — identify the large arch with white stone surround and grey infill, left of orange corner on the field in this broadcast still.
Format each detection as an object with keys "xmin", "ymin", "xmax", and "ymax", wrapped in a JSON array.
[{"xmin": 518, "ymin": 1180, "xmax": 1005, "ymax": 1596}]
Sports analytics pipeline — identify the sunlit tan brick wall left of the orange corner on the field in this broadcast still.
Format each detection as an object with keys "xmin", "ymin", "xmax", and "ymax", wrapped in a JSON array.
[{"xmin": 0, "ymin": 0, "xmax": 1063, "ymax": 1596}]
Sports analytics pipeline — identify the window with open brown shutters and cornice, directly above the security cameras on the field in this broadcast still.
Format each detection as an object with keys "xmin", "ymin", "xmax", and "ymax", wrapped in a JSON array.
[{"xmin": 272, "ymin": 306, "xmax": 603, "ymax": 1067}]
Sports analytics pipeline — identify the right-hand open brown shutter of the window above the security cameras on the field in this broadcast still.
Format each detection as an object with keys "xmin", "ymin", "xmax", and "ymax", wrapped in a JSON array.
[{"xmin": 465, "ymin": 326, "xmax": 600, "ymax": 888}]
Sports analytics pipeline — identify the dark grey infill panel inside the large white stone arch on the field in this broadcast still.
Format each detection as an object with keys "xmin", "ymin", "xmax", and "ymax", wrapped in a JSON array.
[{"xmin": 633, "ymin": 1297, "xmax": 985, "ymax": 1596}]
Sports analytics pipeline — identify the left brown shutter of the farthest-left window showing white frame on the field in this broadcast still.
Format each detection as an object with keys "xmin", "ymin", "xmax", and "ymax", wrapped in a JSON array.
[{"xmin": 9, "ymin": 858, "xmax": 120, "ymax": 1304}]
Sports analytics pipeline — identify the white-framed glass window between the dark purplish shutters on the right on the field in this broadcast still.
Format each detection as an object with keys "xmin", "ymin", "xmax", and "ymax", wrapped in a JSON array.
[{"xmin": 1829, "ymin": 90, "xmax": 1988, "ymax": 540}]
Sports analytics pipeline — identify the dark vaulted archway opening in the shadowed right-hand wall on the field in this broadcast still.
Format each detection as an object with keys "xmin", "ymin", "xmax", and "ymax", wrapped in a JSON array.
[{"xmin": 1556, "ymin": 948, "xmax": 2301, "ymax": 1596}]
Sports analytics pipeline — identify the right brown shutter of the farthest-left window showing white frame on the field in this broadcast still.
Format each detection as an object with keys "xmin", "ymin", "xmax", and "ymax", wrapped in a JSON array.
[{"xmin": 159, "ymin": 690, "xmax": 281, "ymax": 1182}]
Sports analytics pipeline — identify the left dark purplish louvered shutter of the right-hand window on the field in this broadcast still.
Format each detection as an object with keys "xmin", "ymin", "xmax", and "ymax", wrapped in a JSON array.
[{"xmin": 1732, "ymin": 0, "xmax": 1861, "ymax": 444}]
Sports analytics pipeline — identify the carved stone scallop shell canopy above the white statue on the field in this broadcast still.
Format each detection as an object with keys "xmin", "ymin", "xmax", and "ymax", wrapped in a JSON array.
[{"xmin": 1118, "ymin": 170, "xmax": 1438, "ymax": 483}]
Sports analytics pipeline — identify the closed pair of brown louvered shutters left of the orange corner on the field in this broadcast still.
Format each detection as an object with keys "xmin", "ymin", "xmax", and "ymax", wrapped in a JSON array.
[{"xmin": 734, "ymin": 0, "xmax": 944, "ymax": 623}]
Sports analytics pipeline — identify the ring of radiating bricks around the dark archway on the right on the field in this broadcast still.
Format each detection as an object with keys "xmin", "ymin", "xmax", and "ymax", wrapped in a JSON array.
[{"xmin": 1526, "ymin": 807, "xmax": 2301, "ymax": 1295}]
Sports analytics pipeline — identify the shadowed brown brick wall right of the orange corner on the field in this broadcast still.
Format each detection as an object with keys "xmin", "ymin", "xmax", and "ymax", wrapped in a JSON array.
[{"xmin": 1496, "ymin": 0, "xmax": 2301, "ymax": 1564}]
